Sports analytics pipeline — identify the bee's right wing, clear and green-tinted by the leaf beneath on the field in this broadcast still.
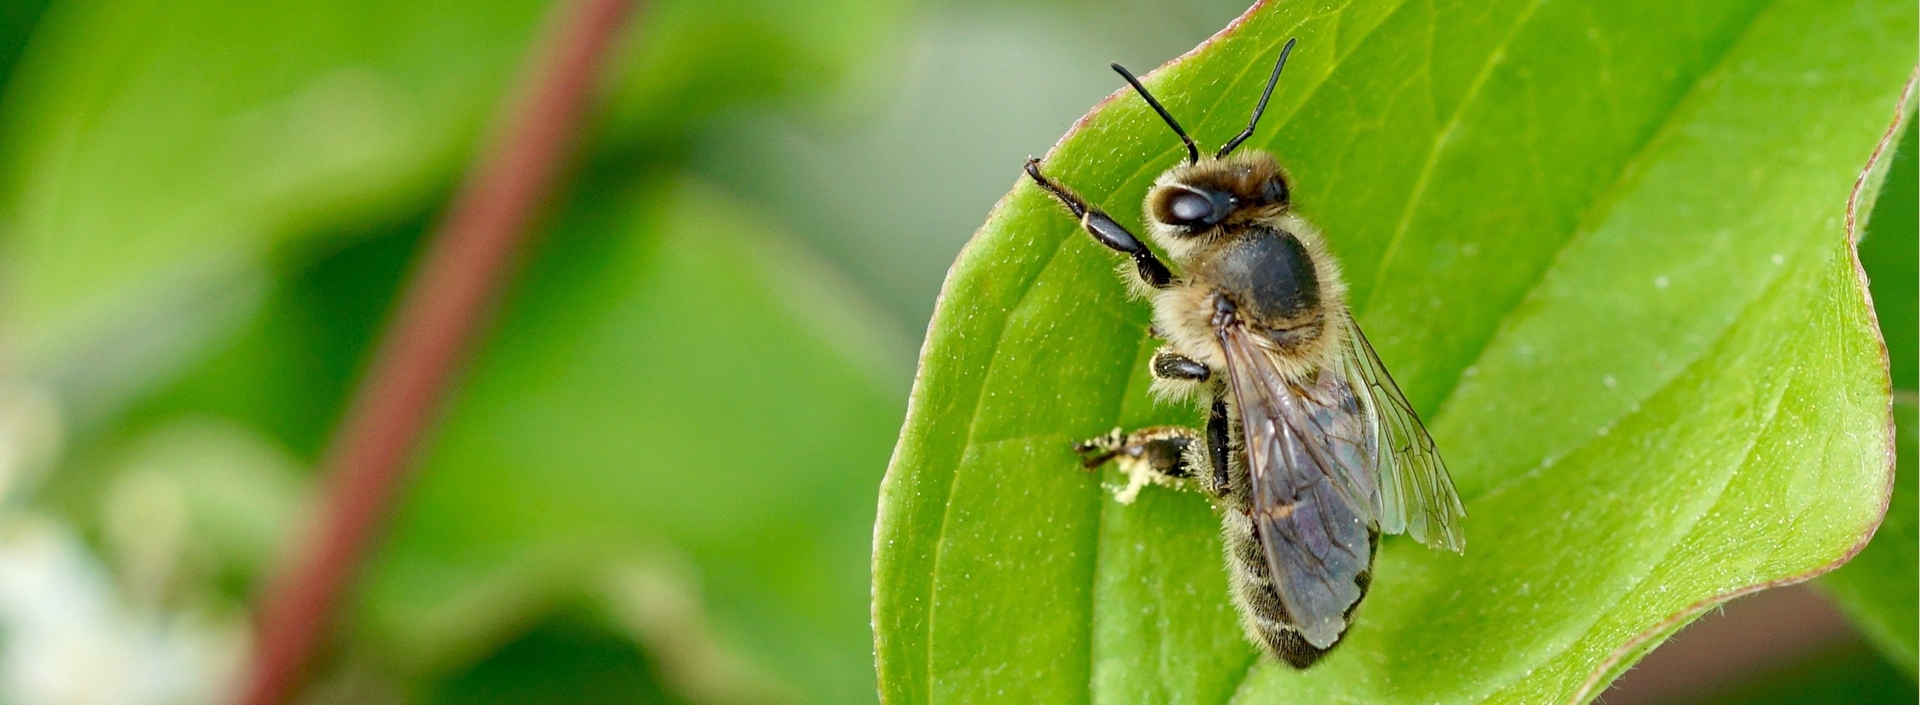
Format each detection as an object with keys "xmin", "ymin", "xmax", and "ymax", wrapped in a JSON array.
[{"xmin": 1346, "ymin": 319, "xmax": 1467, "ymax": 553}]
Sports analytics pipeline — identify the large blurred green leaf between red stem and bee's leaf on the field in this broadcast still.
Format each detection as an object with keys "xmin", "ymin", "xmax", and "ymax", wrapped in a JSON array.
[{"xmin": 361, "ymin": 181, "xmax": 906, "ymax": 703}]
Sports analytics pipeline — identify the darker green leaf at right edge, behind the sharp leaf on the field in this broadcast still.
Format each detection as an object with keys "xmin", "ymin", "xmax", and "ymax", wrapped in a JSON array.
[{"xmin": 1820, "ymin": 117, "xmax": 1920, "ymax": 676}]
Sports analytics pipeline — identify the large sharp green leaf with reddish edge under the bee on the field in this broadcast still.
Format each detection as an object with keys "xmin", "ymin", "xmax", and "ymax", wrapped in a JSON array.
[{"xmin": 874, "ymin": 0, "xmax": 1916, "ymax": 703}]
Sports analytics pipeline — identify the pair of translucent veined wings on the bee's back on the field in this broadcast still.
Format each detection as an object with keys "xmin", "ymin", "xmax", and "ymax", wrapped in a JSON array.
[{"xmin": 1217, "ymin": 311, "xmax": 1467, "ymax": 649}]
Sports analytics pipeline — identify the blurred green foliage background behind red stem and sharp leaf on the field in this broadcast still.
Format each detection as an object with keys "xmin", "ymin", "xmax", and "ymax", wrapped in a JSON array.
[{"xmin": 0, "ymin": 0, "xmax": 1896, "ymax": 705}]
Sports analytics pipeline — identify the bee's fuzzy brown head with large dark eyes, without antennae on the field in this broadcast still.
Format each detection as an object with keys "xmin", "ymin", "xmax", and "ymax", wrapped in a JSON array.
[{"xmin": 1146, "ymin": 152, "xmax": 1292, "ymax": 238}]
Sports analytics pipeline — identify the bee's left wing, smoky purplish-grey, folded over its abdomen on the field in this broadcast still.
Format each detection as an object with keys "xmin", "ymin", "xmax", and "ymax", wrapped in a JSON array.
[{"xmin": 1217, "ymin": 327, "xmax": 1377, "ymax": 649}]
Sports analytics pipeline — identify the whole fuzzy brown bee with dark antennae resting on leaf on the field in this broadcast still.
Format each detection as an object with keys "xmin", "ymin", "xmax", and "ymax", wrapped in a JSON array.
[{"xmin": 1025, "ymin": 40, "xmax": 1467, "ymax": 669}]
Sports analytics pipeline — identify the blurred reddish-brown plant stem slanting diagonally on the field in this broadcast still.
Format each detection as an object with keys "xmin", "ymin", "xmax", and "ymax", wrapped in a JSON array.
[{"xmin": 242, "ymin": 0, "xmax": 634, "ymax": 705}]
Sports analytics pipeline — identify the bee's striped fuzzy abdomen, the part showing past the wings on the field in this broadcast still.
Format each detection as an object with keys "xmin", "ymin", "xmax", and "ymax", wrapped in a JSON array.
[{"xmin": 1221, "ymin": 509, "xmax": 1379, "ymax": 669}]
